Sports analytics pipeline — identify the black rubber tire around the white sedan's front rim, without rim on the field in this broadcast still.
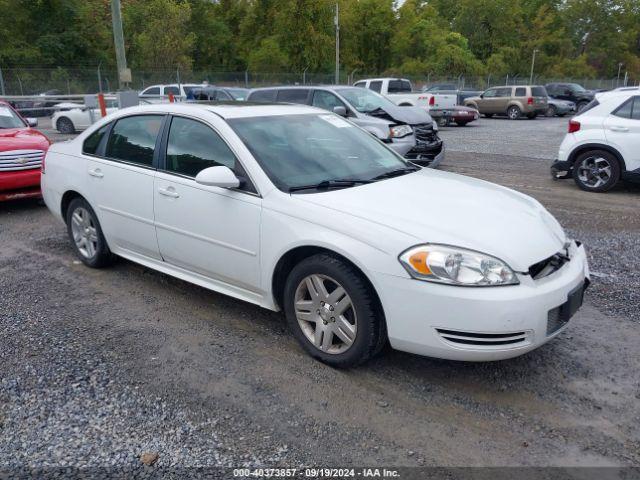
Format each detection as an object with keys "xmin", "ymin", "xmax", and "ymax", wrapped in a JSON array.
[{"xmin": 284, "ymin": 253, "xmax": 387, "ymax": 368}]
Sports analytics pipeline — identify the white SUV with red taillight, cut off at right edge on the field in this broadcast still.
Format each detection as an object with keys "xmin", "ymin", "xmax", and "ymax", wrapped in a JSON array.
[{"xmin": 551, "ymin": 88, "xmax": 640, "ymax": 192}]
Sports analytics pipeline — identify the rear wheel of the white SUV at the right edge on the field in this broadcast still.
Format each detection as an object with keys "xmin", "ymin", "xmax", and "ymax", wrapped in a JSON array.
[{"xmin": 573, "ymin": 150, "xmax": 620, "ymax": 192}]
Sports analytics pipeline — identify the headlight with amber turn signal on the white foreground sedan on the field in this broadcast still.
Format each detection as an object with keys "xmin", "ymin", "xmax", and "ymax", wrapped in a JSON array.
[{"xmin": 398, "ymin": 243, "xmax": 520, "ymax": 287}]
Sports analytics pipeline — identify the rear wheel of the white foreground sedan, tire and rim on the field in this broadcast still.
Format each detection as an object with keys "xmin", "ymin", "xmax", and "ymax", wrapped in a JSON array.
[{"xmin": 66, "ymin": 198, "xmax": 113, "ymax": 268}]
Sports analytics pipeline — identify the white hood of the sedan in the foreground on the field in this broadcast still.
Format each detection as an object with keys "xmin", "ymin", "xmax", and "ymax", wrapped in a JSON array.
[{"xmin": 295, "ymin": 169, "xmax": 566, "ymax": 272}]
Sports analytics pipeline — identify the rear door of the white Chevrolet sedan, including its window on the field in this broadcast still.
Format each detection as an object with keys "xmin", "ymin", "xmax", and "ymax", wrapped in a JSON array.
[{"xmin": 87, "ymin": 114, "xmax": 165, "ymax": 259}]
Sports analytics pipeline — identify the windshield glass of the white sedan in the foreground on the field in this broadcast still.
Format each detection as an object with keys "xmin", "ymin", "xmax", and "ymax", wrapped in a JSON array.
[{"xmin": 228, "ymin": 113, "xmax": 407, "ymax": 192}]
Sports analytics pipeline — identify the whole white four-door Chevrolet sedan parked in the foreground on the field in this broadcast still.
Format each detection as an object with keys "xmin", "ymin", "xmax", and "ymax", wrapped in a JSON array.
[{"xmin": 42, "ymin": 103, "xmax": 589, "ymax": 367}]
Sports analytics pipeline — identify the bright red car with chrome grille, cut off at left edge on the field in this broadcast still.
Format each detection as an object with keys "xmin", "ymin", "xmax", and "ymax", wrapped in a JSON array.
[{"xmin": 0, "ymin": 101, "xmax": 51, "ymax": 201}]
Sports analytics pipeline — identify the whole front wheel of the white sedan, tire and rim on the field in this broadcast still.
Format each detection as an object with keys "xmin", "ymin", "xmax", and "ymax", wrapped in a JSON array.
[{"xmin": 284, "ymin": 254, "xmax": 386, "ymax": 368}]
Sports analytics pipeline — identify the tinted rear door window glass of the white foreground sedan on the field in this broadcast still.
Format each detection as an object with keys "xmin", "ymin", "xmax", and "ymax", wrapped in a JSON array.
[{"xmin": 106, "ymin": 115, "xmax": 163, "ymax": 167}]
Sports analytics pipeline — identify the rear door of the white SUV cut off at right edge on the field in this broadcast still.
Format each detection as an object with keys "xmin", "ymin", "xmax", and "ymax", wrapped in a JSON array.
[{"xmin": 604, "ymin": 96, "xmax": 640, "ymax": 170}]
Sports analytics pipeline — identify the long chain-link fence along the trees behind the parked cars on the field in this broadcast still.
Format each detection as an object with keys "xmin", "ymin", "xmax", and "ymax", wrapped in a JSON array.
[{"xmin": 0, "ymin": 67, "xmax": 640, "ymax": 95}]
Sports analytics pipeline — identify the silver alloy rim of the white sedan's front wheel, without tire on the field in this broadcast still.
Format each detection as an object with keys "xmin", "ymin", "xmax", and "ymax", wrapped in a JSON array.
[{"xmin": 294, "ymin": 274, "xmax": 358, "ymax": 354}]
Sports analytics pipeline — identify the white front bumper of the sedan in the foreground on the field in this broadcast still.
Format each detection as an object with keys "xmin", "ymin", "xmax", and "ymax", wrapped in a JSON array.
[{"xmin": 375, "ymin": 243, "xmax": 589, "ymax": 361}]
